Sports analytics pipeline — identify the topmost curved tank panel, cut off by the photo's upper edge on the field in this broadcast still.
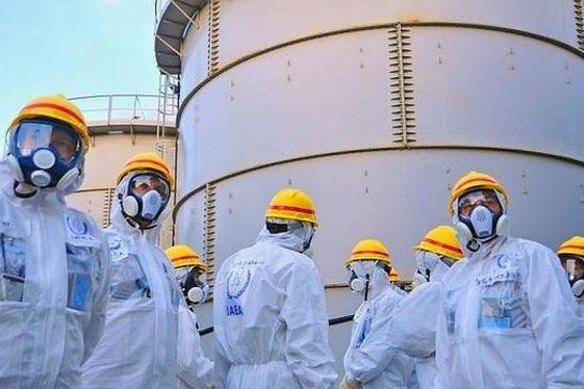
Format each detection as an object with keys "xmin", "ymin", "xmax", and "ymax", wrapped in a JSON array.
[{"xmin": 183, "ymin": 0, "xmax": 581, "ymax": 72}]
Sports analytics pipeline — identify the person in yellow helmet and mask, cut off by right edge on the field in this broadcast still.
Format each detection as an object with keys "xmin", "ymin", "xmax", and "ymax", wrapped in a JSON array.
[{"xmin": 557, "ymin": 236, "xmax": 584, "ymax": 316}]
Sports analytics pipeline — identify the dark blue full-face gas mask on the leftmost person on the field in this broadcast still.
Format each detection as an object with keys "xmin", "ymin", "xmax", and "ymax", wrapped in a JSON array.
[{"xmin": 7, "ymin": 119, "xmax": 84, "ymax": 190}]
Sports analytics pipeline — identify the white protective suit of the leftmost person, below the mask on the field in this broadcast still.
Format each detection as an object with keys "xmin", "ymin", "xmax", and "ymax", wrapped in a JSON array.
[{"xmin": 0, "ymin": 161, "xmax": 109, "ymax": 388}]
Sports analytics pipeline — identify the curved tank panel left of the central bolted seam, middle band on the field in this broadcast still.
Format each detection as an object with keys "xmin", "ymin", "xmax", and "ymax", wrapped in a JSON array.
[{"xmin": 180, "ymin": 31, "xmax": 391, "ymax": 186}]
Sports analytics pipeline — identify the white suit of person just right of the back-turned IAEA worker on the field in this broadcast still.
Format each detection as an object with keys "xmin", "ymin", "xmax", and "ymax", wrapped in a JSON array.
[{"xmin": 344, "ymin": 261, "xmax": 414, "ymax": 389}]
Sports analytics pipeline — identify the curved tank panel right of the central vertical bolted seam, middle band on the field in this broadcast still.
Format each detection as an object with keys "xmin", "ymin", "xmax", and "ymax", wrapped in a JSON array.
[{"xmin": 404, "ymin": 27, "xmax": 584, "ymax": 159}]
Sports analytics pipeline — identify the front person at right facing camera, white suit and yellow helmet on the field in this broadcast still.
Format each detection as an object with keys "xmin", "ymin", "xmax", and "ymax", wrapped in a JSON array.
[{"xmin": 436, "ymin": 172, "xmax": 584, "ymax": 389}]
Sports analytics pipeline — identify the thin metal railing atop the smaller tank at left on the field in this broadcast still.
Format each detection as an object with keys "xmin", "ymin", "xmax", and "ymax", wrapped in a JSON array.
[{"xmin": 70, "ymin": 94, "xmax": 174, "ymax": 125}]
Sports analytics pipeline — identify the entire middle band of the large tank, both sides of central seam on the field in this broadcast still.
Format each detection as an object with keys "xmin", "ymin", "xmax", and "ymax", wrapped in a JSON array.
[{"xmin": 180, "ymin": 27, "xmax": 584, "ymax": 185}]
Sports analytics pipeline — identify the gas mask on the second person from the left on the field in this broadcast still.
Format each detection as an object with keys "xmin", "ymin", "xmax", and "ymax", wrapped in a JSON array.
[{"xmin": 120, "ymin": 173, "xmax": 170, "ymax": 228}]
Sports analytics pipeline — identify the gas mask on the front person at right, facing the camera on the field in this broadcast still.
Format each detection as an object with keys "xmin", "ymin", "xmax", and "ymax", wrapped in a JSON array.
[{"xmin": 454, "ymin": 189, "xmax": 509, "ymax": 252}]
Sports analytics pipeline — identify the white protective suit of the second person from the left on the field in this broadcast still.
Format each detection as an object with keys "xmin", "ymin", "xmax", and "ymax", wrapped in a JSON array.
[{"xmin": 83, "ymin": 176, "xmax": 183, "ymax": 389}]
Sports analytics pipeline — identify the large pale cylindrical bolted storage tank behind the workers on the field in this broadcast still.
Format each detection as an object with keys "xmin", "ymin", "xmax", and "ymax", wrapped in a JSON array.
[{"xmin": 156, "ymin": 0, "xmax": 584, "ymax": 376}]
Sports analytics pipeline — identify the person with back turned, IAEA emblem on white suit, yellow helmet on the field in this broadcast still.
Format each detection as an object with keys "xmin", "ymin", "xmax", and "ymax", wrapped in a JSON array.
[{"xmin": 213, "ymin": 188, "xmax": 337, "ymax": 389}]
